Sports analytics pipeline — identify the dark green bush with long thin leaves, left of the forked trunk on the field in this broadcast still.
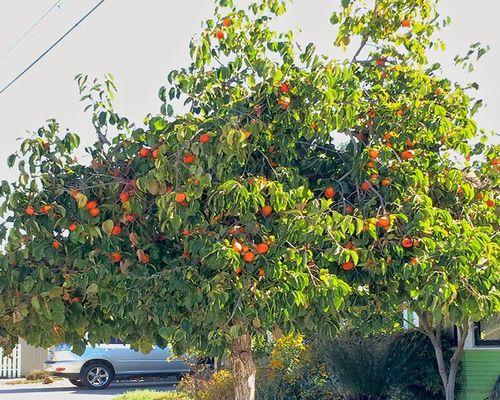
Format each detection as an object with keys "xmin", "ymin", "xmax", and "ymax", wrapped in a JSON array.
[{"xmin": 320, "ymin": 332, "xmax": 458, "ymax": 400}]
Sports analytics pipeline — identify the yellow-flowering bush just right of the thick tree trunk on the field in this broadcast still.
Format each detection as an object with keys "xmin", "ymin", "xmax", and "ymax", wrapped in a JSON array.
[{"xmin": 257, "ymin": 335, "xmax": 334, "ymax": 400}]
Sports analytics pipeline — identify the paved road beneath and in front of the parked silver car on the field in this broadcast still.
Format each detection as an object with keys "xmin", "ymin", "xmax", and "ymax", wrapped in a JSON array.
[{"xmin": 0, "ymin": 379, "xmax": 178, "ymax": 400}]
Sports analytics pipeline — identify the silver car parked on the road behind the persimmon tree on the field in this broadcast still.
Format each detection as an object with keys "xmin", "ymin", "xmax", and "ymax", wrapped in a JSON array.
[{"xmin": 45, "ymin": 340, "xmax": 190, "ymax": 389}]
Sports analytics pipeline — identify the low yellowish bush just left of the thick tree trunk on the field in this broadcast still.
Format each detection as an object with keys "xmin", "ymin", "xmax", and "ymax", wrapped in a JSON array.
[{"xmin": 178, "ymin": 370, "xmax": 234, "ymax": 400}]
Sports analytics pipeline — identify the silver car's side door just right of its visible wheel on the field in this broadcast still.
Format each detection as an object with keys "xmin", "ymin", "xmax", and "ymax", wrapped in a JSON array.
[{"xmin": 100, "ymin": 339, "xmax": 146, "ymax": 375}]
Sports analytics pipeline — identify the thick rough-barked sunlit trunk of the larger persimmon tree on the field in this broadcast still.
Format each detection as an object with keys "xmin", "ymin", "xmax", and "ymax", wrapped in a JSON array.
[{"xmin": 231, "ymin": 333, "xmax": 256, "ymax": 400}]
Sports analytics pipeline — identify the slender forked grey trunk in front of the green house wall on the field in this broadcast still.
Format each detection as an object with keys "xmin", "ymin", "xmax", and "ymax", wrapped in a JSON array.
[{"xmin": 417, "ymin": 313, "xmax": 469, "ymax": 400}]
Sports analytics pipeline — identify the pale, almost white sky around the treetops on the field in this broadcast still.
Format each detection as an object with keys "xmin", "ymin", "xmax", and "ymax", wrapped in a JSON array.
[{"xmin": 0, "ymin": 0, "xmax": 500, "ymax": 179}]
